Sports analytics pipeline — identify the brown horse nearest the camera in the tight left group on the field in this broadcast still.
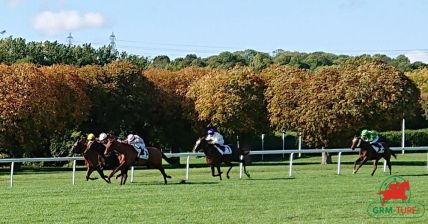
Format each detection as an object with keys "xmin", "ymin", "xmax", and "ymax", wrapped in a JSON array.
[{"xmin": 104, "ymin": 137, "xmax": 173, "ymax": 185}]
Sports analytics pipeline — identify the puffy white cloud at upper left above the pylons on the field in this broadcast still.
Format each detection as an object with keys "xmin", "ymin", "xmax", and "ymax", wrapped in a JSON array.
[{"xmin": 33, "ymin": 11, "xmax": 105, "ymax": 35}]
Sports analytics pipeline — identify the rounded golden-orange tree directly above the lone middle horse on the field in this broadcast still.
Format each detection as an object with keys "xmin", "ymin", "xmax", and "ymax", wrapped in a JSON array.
[{"xmin": 187, "ymin": 69, "xmax": 268, "ymax": 136}]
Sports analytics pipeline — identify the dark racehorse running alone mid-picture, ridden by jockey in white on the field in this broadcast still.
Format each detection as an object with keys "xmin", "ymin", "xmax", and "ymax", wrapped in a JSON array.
[{"xmin": 193, "ymin": 137, "xmax": 250, "ymax": 180}]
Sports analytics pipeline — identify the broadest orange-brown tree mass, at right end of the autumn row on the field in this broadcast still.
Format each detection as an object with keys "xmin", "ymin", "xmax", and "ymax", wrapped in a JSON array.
[{"xmin": 265, "ymin": 63, "xmax": 419, "ymax": 147}]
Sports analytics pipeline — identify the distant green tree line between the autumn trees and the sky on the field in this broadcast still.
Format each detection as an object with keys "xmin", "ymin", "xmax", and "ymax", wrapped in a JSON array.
[{"xmin": 0, "ymin": 37, "xmax": 428, "ymax": 72}]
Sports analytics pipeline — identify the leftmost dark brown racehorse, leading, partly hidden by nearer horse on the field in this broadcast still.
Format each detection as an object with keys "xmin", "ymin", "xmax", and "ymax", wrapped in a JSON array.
[{"xmin": 70, "ymin": 139, "xmax": 119, "ymax": 183}]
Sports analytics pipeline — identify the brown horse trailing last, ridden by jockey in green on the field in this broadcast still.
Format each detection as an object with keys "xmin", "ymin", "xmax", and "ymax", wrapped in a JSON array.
[{"xmin": 351, "ymin": 137, "xmax": 397, "ymax": 176}]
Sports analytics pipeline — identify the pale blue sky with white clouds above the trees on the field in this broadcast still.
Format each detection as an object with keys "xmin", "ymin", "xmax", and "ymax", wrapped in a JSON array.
[{"xmin": 0, "ymin": 0, "xmax": 428, "ymax": 63}]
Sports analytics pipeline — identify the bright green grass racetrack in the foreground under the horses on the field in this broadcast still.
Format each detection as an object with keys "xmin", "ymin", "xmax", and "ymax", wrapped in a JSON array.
[{"xmin": 0, "ymin": 153, "xmax": 428, "ymax": 224}]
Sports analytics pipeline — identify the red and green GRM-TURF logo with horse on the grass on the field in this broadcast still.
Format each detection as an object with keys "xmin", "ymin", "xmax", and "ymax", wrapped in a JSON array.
[{"xmin": 367, "ymin": 176, "xmax": 425, "ymax": 218}]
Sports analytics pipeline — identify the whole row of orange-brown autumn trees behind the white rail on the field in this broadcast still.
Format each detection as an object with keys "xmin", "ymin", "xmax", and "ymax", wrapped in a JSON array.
[{"xmin": 0, "ymin": 57, "xmax": 426, "ymax": 157}]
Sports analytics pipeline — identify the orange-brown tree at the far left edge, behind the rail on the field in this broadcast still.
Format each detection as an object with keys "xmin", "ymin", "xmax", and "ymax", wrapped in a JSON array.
[{"xmin": 0, "ymin": 64, "xmax": 87, "ymax": 157}]
